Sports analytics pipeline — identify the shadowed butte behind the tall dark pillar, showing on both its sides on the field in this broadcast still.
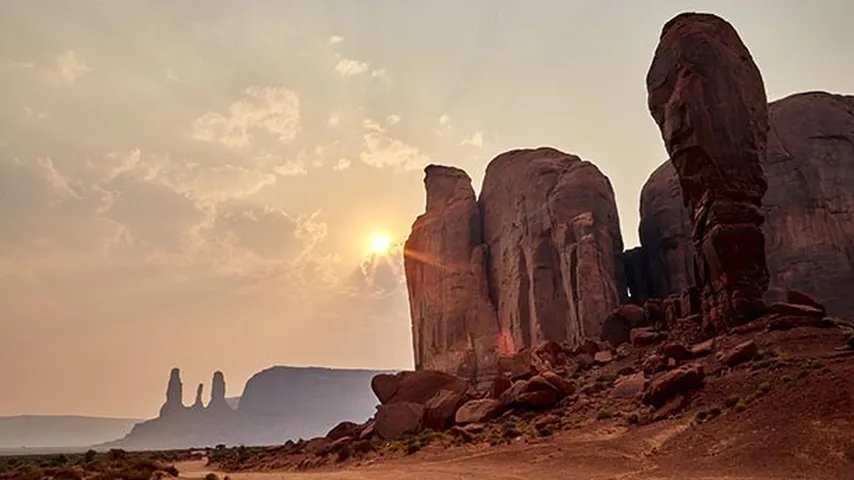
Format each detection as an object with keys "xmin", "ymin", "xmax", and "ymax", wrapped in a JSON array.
[{"xmin": 637, "ymin": 92, "xmax": 854, "ymax": 315}]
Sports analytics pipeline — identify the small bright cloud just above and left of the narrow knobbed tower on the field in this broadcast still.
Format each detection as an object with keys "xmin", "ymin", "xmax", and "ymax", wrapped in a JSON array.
[{"xmin": 359, "ymin": 120, "xmax": 430, "ymax": 170}]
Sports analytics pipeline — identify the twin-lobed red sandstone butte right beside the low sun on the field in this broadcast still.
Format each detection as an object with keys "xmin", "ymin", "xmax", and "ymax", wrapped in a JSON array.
[{"xmin": 405, "ymin": 148, "xmax": 626, "ymax": 381}]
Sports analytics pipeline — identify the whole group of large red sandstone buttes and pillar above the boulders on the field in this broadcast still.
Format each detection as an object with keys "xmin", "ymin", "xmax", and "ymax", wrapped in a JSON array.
[{"xmin": 405, "ymin": 13, "xmax": 854, "ymax": 385}]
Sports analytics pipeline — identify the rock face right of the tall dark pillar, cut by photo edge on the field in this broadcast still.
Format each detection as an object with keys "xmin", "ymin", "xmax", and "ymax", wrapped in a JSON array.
[{"xmin": 764, "ymin": 92, "xmax": 854, "ymax": 315}]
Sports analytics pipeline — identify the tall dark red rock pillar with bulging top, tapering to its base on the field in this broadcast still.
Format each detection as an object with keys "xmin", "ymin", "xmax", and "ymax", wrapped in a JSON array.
[{"xmin": 647, "ymin": 13, "xmax": 769, "ymax": 331}]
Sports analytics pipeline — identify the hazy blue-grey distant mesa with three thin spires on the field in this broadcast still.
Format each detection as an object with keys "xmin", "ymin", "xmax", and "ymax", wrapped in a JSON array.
[{"xmin": 98, "ymin": 366, "xmax": 389, "ymax": 450}]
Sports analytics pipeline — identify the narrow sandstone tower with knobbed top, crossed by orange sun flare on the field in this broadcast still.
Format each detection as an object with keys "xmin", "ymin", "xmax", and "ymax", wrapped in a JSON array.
[{"xmin": 404, "ymin": 165, "xmax": 499, "ymax": 379}]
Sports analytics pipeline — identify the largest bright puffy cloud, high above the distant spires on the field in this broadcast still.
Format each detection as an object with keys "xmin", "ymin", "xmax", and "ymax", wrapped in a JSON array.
[{"xmin": 190, "ymin": 86, "xmax": 300, "ymax": 149}]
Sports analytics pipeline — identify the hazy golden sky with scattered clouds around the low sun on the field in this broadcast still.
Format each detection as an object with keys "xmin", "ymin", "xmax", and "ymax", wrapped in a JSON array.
[{"xmin": 0, "ymin": 0, "xmax": 854, "ymax": 417}]
